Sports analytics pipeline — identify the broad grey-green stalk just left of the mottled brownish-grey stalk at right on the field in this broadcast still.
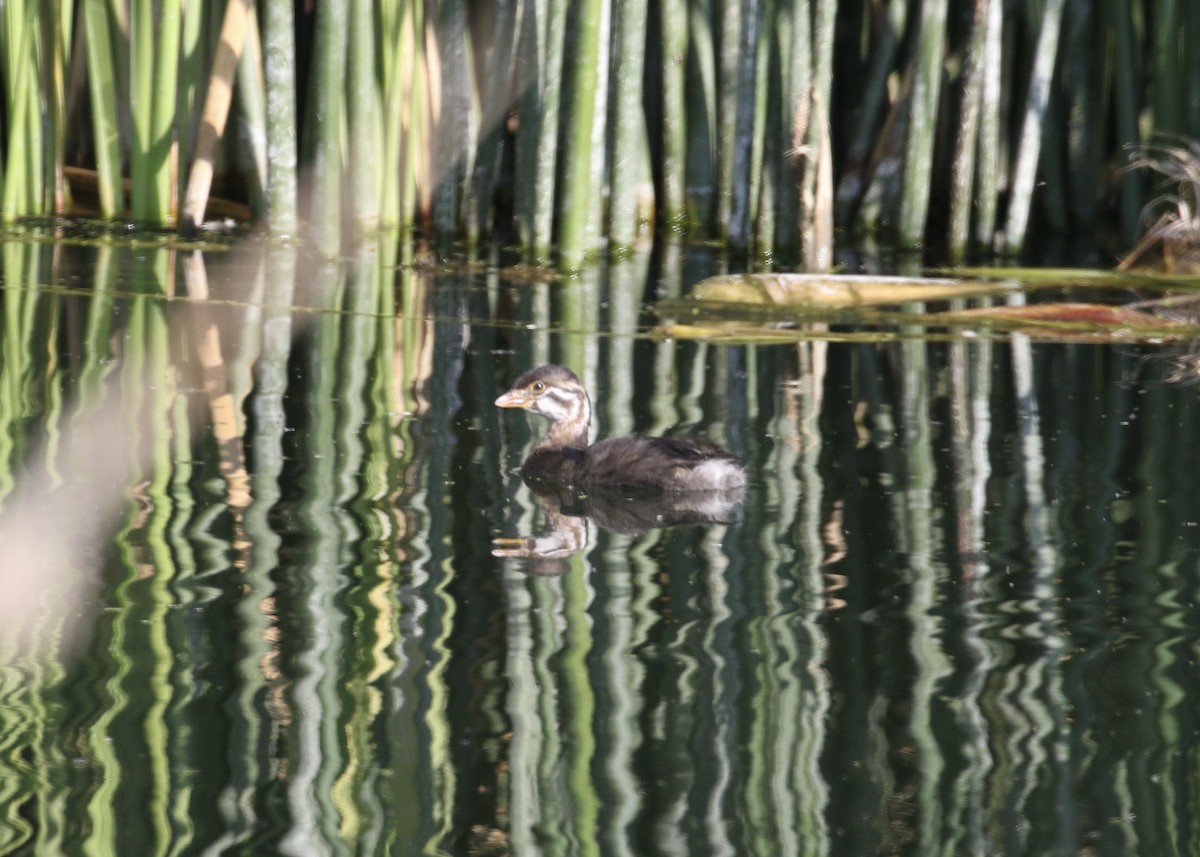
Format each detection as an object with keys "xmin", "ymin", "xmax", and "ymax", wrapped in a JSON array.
[{"xmin": 898, "ymin": 0, "xmax": 946, "ymax": 248}]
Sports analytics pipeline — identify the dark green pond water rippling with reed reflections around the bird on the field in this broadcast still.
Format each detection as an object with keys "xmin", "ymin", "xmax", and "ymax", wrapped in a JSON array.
[{"xmin": 0, "ymin": 236, "xmax": 1200, "ymax": 857}]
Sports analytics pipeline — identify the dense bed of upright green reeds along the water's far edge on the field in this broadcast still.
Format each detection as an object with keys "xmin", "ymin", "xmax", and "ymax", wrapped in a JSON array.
[{"xmin": 0, "ymin": 0, "xmax": 1200, "ymax": 269}]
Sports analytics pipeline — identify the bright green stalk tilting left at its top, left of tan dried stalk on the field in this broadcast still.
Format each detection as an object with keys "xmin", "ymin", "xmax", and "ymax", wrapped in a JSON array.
[{"xmin": 83, "ymin": 0, "xmax": 125, "ymax": 220}]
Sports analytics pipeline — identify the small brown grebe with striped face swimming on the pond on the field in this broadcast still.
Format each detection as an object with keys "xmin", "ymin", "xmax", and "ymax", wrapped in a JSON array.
[{"xmin": 496, "ymin": 365, "xmax": 746, "ymax": 499}]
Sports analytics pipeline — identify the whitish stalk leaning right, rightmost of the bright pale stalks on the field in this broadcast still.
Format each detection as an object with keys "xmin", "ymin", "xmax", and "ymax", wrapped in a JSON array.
[{"xmin": 1004, "ymin": 0, "xmax": 1064, "ymax": 253}]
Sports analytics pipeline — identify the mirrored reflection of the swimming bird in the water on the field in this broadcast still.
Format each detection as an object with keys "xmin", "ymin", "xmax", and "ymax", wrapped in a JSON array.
[{"xmin": 492, "ymin": 480, "xmax": 745, "ymax": 576}]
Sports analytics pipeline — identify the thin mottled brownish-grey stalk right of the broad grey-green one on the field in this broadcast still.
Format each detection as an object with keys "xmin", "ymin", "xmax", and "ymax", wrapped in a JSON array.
[{"xmin": 947, "ymin": 0, "xmax": 997, "ymax": 262}]
